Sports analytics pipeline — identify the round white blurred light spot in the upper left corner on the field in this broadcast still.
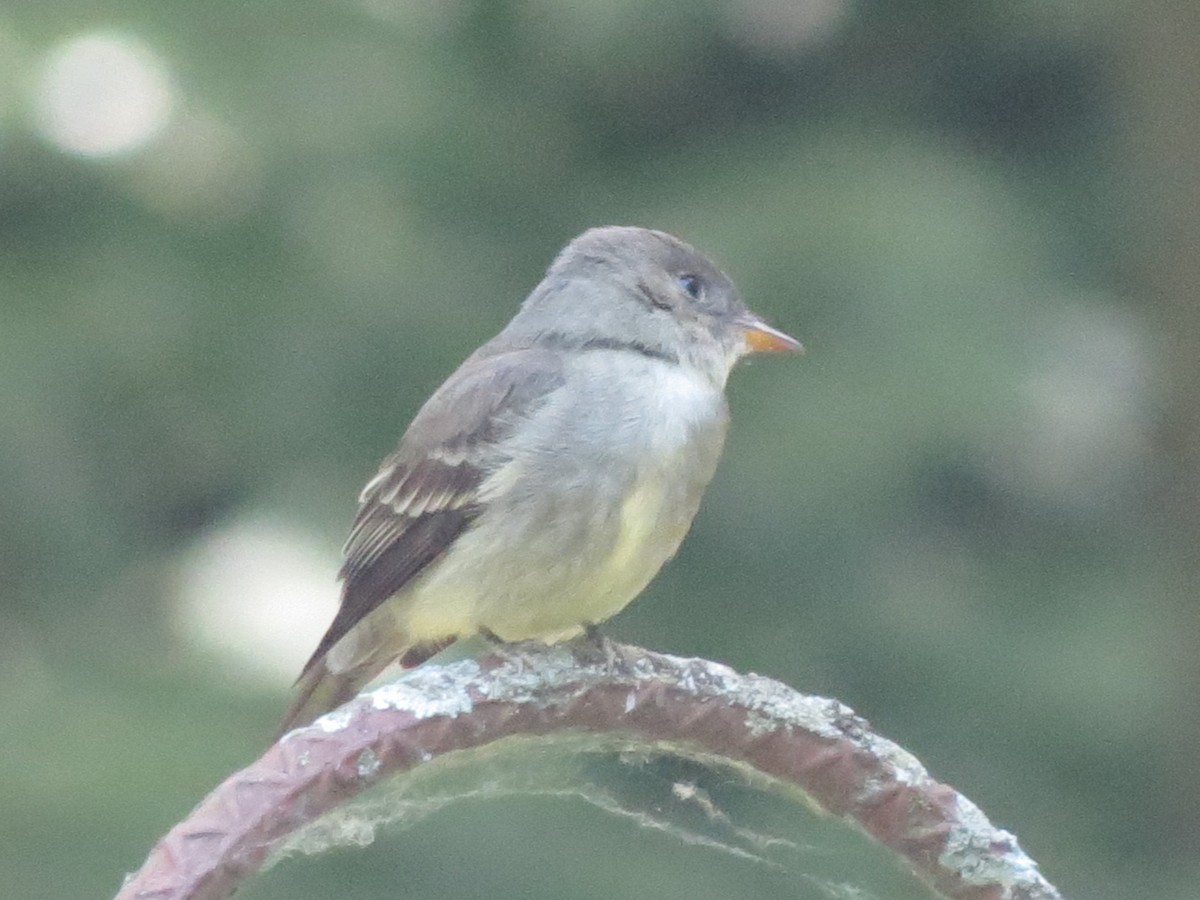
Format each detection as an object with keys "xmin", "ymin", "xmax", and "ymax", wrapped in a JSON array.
[{"xmin": 35, "ymin": 34, "xmax": 174, "ymax": 157}]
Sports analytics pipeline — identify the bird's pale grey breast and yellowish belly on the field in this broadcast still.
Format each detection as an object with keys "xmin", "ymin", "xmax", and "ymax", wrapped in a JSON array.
[{"xmin": 410, "ymin": 354, "xmax": 726, "ymax": 640}]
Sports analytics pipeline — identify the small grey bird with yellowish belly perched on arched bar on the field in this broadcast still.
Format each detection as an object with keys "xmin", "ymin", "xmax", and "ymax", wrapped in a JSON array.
[{"xmin": 278, "ymin": 226, "xmax": 803, "ymax": 736}]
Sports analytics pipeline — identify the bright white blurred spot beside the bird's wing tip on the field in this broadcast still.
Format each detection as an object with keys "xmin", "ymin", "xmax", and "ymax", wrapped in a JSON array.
[{"xmin": 176, "ymin": 520, "xmax": 338, "ymax": 685}]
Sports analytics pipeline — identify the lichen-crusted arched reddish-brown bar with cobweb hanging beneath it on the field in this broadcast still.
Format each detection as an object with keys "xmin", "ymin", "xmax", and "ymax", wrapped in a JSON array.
[{"xmin": 114, "ymin": 641, "xmax": 1058, "ymax": 900}]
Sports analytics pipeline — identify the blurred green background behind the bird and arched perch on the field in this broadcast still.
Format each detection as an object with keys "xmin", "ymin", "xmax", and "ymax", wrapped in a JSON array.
[{"xmin": 0, "ymin": 0, "xmax": 1200, "ymax": 899}]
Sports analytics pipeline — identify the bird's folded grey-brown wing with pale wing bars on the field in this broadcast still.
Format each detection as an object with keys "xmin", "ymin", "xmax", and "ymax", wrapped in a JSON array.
[{"xmin": 297, "ymin": 349, "xmax": 563, "ymax": 672}]
